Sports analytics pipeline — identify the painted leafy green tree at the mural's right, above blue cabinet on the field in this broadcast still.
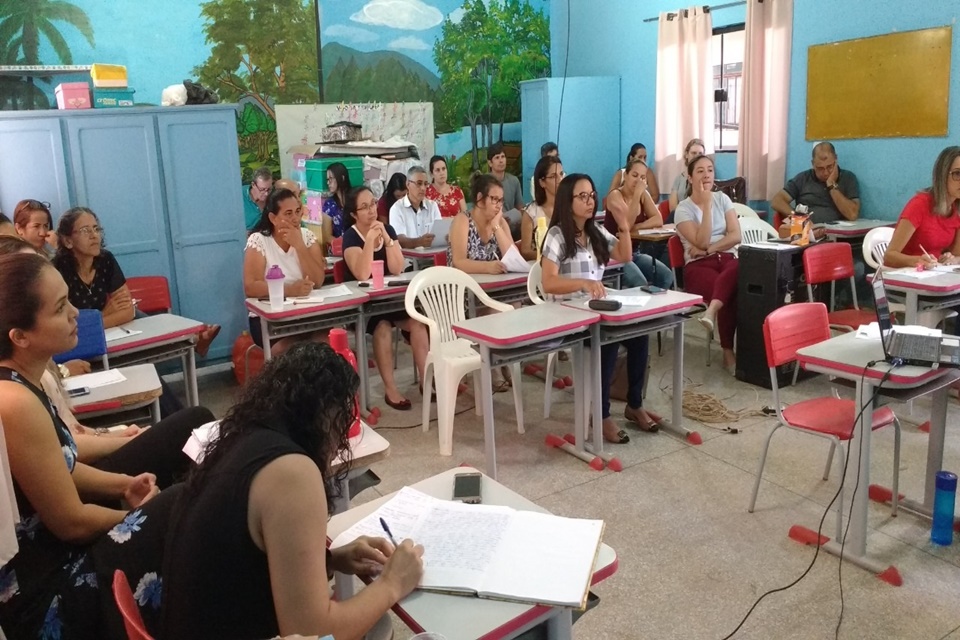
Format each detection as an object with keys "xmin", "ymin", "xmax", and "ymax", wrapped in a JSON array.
[{"xmin": 433, "ymin": 0, "xmax": 550, "ymax": 170}]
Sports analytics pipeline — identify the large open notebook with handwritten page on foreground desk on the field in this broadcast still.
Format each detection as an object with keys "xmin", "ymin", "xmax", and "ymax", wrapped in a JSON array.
[{"xmin": 331, "ymin": 487, "xmax": 603, "ymax": 608}]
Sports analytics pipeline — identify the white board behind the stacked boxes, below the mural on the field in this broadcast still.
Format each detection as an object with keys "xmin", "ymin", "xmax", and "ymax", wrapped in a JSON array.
[{"xmin": 277, "ymin": 102, "xmax": 434, "ymax": 177}]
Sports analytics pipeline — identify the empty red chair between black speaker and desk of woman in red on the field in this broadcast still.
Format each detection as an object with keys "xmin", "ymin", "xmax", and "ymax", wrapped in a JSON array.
[{"xmin": 803, "ymin": 242, "xmax": 877, "ymax": 332}]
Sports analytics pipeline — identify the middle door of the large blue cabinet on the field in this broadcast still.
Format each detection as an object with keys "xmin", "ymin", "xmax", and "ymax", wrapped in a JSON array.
[{"xmin": 65, "ymin": 113, "xmax": 179, "ymax": 302}]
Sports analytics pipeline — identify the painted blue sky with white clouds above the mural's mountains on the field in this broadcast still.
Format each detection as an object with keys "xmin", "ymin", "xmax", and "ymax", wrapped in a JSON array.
[{"xmin": 320, "ymin": 0, "xmax": 550, "ymax": 73}]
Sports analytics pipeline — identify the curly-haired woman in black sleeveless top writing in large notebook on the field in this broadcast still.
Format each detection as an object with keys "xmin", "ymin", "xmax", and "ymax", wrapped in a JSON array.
[{"xmin": 160, "ymin": 342, "xmax": 423, "ymax": 640}]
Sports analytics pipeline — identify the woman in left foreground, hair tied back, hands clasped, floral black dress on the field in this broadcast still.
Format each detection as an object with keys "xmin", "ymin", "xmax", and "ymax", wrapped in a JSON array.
[{"xmin": 0, "ymin": 254, "xmax": 165, "ymax": 640}]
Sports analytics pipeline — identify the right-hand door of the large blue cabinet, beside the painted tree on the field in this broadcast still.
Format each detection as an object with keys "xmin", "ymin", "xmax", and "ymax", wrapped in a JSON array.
[{"xmin": 157, "ymin": 106, "xmax": 247, "ymax": 358}]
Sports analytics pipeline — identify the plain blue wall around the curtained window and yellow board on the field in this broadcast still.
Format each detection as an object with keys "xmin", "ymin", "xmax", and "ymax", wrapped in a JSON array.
[{"xmin": 550, "ymin": 0, "xmax": 960, "ymax": 219}]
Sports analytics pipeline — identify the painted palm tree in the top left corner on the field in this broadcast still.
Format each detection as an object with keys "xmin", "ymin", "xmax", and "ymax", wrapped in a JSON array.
[{"xmin": 0, "ymin": 0, "xmax": 94, "ymax": 109}]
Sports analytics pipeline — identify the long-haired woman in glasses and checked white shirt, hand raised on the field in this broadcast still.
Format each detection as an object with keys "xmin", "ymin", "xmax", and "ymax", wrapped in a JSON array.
[{"xmin": 540, "ymin": 173, "xmax": 661, "ymax": 444}]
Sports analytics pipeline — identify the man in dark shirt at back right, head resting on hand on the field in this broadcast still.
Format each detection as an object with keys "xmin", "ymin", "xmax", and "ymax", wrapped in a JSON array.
[{"xmin": 770, "ymin": 142, "xmax": 860, "ymax": 226}]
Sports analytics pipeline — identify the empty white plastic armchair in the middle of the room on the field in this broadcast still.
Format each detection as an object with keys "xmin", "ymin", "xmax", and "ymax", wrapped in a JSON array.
[{"xmin": 404, "ymin": 267, "xmax": 524, "ymax": 456}]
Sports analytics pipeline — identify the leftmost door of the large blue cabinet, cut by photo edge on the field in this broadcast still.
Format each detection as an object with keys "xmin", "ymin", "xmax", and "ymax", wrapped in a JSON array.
[{"xmin": 0, "ymin": 115, "xmax": 70, "ymax": 220}]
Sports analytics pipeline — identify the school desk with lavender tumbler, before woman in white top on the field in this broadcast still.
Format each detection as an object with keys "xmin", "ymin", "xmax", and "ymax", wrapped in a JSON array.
[{"xmin": 244, "ymin": 287, "xmax": 369, "ymax": 409}]
